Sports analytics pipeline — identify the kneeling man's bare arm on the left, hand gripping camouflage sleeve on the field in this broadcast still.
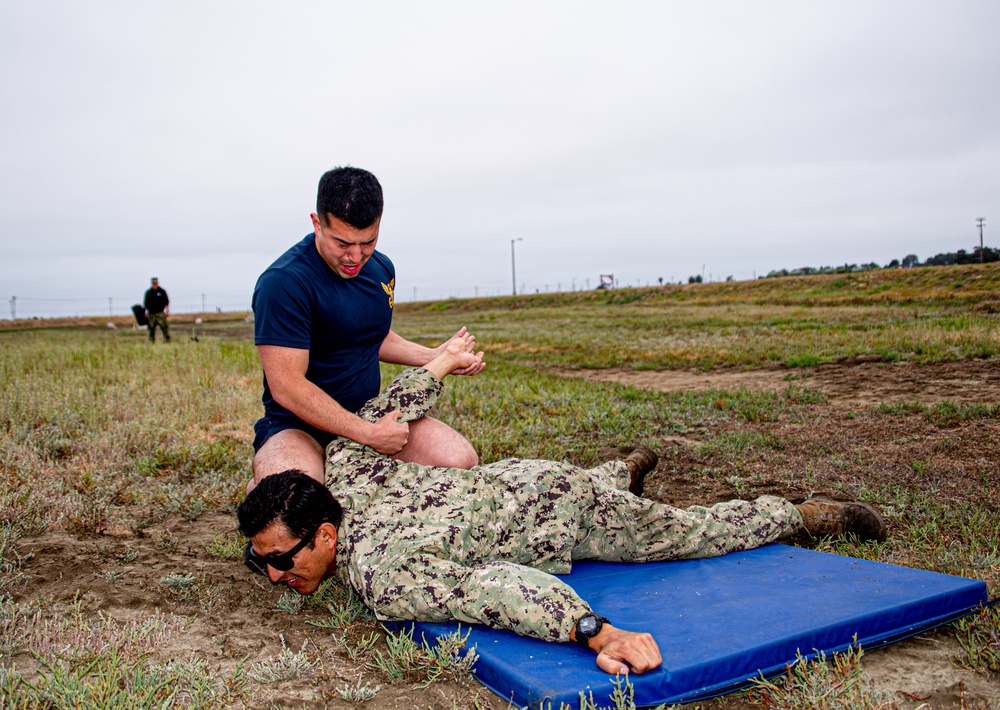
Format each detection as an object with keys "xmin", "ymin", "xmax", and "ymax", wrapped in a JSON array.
[{"xmin": 257, "ymin": 345, "xmax": 409, "ymax": 456}]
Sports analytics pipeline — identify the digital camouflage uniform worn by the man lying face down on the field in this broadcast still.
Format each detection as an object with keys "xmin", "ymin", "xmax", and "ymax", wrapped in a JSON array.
[{"xmin": 326, "ymin": 369, "xmax": 801, "ymax": 642}]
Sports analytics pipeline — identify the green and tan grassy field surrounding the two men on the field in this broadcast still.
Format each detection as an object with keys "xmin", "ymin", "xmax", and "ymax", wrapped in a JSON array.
[{"xmin": 0, "ymin": 265, "xmax": 1000, "ymax": 708}]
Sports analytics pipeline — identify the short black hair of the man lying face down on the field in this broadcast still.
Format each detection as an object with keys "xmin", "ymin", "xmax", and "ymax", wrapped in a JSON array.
[{"xmin": 236, "ymin": 468, "xmax": 344, "ymax": 538}]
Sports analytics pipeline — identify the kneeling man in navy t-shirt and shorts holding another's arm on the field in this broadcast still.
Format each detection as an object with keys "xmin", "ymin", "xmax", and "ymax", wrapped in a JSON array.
[{"xmin": 247, "ymin": 167, "xmax": 484, "ymax": 491}]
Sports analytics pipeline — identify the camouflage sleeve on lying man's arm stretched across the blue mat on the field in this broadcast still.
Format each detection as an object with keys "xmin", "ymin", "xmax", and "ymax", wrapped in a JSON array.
[{"xmin": 360, "ymin": 553, "xmax": 590, "ymax": 643}]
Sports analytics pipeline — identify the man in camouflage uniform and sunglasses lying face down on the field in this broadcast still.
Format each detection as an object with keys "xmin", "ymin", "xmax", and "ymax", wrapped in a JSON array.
[{"xmin": 239, "ymin": 338, "xmax": 886, "ymax": 673}]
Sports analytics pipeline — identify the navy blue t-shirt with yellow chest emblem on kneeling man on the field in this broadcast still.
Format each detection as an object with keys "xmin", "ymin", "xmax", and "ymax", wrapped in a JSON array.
[{"xmin": 252, "ymin": 234, "xmax": 396, "ymax": 420}]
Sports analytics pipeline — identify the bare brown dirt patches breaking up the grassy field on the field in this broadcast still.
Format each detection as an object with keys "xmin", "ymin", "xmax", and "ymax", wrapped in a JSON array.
[{"xmin": 14, "ymin": 360, "xmax": 1000, "ymax": 710}]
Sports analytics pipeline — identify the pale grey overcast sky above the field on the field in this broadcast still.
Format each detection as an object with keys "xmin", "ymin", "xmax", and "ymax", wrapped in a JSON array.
[{"xmin": 0, "ymin": 0, "xmax": 1000, "ymax": 318}]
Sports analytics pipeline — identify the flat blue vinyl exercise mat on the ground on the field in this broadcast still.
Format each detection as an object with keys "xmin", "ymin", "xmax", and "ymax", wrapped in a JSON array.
[{"xmin": 402, "ymin": 545, "xmax": 988, "ymax": 710}]
